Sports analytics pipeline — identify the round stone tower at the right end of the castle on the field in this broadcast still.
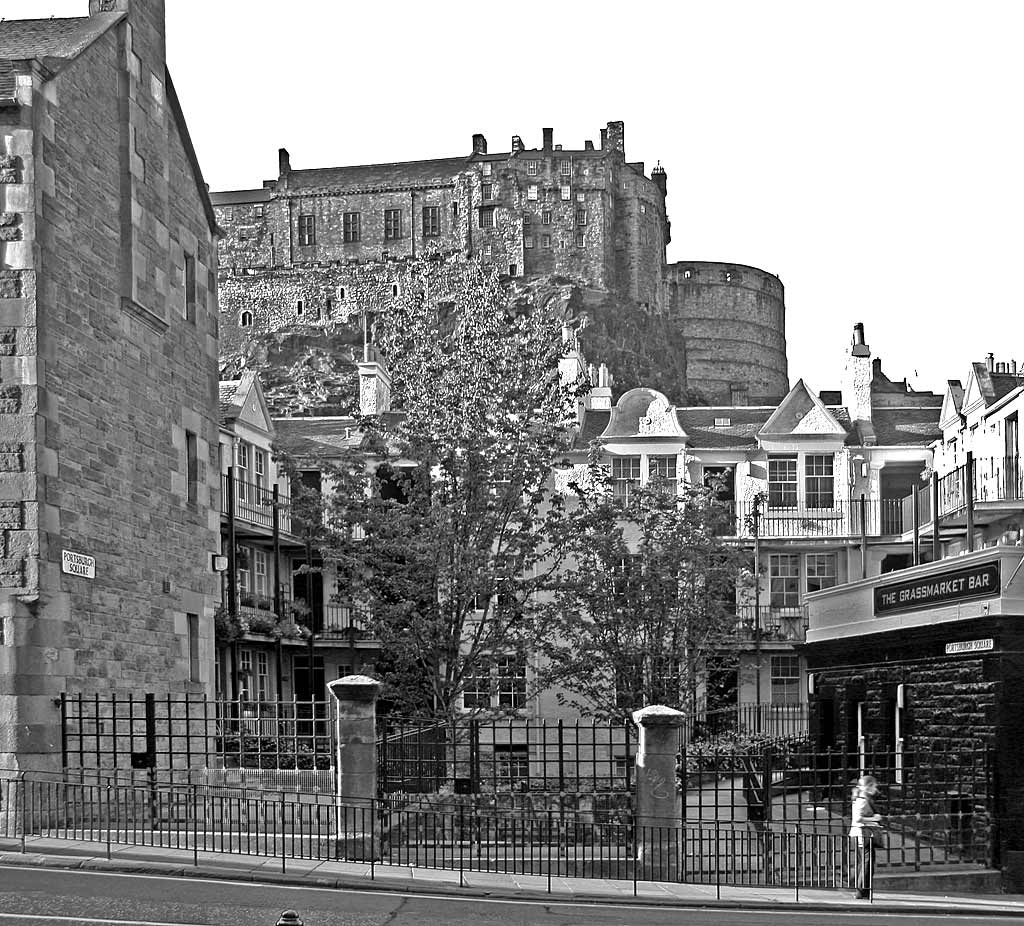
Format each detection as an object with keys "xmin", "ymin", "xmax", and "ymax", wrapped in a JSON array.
[{"xmin": 665, "ymin": 260, "xmax": 790, "ymax": 405}]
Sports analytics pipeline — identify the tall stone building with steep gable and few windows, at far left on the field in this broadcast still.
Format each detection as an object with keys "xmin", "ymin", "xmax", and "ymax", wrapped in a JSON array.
[{"xmin": 0, "ymin": 0, "xmax": 218, "ymax": 769}]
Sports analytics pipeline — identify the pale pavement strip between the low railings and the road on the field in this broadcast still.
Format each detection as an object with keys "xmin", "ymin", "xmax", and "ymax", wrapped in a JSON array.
[{"xmin": 0, "ymin": 837, "xmax": 1024, "ymax": 917}]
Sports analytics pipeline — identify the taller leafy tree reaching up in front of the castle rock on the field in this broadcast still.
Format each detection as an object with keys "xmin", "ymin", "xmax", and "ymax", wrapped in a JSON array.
[{"xmin": 280, "ymin": 261, "xmax": 582, "ymax": 718}]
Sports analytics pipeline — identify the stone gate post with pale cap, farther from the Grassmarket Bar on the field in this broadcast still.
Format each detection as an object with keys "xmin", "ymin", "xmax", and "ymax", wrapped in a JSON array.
[{"xmin": 327, "ymin": 675, "xmax": 381, "ymax": 859}]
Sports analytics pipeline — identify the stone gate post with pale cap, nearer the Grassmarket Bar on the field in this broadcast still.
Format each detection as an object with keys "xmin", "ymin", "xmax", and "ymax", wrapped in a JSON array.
[{"xmin": 633, "ymin": 704, "xmax": 684, "ymax": 881}]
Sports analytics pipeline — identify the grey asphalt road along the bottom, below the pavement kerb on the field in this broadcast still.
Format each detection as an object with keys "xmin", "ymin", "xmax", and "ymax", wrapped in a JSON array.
[{"xmin": 0, "ymin": 866, "xmax": 1006, "ymax": 926}]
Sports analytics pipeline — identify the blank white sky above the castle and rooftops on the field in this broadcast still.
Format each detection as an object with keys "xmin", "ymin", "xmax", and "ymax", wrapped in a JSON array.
[{"xmin": 8, "ymin": 0, "xmax": 1024, "ymax": 391}]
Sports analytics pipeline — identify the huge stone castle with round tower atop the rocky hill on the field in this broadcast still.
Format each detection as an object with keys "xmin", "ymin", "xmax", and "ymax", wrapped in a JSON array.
[{"xmin": 212, "ymin": 122, "xmax": 788, "ymax": 404}]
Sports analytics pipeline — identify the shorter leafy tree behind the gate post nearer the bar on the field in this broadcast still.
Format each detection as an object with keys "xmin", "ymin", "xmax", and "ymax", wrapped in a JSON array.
[{"xmin": 538, "ymin": 463, "xmax": 749, "ymax": 721}]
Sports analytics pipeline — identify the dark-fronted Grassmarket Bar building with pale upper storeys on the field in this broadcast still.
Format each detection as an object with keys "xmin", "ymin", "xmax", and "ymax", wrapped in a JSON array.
[{"xmin": 803, "ymin": 354, "xmax": 1024, "ymax": 890}]
